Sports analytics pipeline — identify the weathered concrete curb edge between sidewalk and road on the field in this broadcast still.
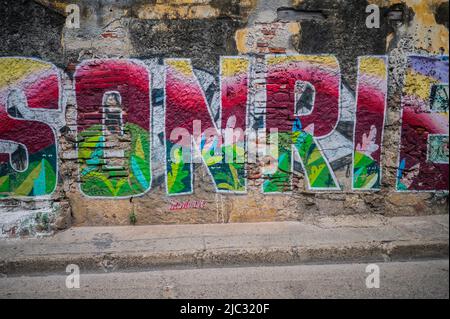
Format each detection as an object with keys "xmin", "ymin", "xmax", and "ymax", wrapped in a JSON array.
[{"xmin": 0, "ymin": 240, "xmax": 449, "ymax": 276}]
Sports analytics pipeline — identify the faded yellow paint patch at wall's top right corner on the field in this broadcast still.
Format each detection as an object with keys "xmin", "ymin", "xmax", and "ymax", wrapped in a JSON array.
[{"xmin": 369, "ymin": 0, "xmax": 449, "ymax": 54}]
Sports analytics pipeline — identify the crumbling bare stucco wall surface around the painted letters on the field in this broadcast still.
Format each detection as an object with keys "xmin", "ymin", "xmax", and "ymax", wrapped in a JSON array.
[{"xmin": 0, "ymin": 0, "xmax": 448, "ymax": 235}]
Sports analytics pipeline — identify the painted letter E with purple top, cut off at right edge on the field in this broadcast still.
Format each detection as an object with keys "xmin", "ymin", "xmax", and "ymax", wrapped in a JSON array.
[{"xmin": 397, "ymin": 55, "xmax": 449, "ymax": 191}]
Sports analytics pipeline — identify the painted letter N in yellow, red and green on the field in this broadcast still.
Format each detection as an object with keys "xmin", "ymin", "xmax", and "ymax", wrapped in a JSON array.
[{"xmin": 164, "ymin": 57, "xmax": 249, "ymax": 195}]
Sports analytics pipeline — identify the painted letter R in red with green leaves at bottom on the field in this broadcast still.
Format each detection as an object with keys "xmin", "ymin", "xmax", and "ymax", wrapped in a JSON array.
[{"xmin": 263, "ymin": 55, "xmax": 341, "ymax": 193}]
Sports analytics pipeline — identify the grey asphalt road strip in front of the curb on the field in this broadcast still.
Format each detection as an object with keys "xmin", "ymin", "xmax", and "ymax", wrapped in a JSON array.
[{"xmin": 0, "ymin": 259, "xmax": 449, "ymax": 299}]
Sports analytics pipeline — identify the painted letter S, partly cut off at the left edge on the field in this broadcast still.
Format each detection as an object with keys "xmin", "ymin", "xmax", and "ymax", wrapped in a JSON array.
[{"xmin": 0, "ymin": 58, "xmax": 62, "ymax": 197}]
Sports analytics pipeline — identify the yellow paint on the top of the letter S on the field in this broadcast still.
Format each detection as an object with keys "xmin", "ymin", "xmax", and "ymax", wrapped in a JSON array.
[{"xmin": 0, "ymin": 58, "xmax": 51, "ymax": 87}]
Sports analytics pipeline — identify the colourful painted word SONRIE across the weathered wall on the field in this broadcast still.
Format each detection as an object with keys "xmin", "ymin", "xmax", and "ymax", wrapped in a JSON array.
[{"xmin": 0, "ymin": 55, "xmax": 449, "ymax": 198}]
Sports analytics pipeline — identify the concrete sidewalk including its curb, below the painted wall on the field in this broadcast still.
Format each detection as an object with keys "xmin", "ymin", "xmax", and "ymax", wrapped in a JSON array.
[{"xmin": 0, "ymin": 215, "xmax": 449, "ymax": 275}]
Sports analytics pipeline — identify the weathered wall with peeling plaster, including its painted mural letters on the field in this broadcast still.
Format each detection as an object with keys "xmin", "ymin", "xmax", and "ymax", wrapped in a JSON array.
[{"xmin": 0, "ymin": 0, "xmax": 448, "ymax": 234}]
